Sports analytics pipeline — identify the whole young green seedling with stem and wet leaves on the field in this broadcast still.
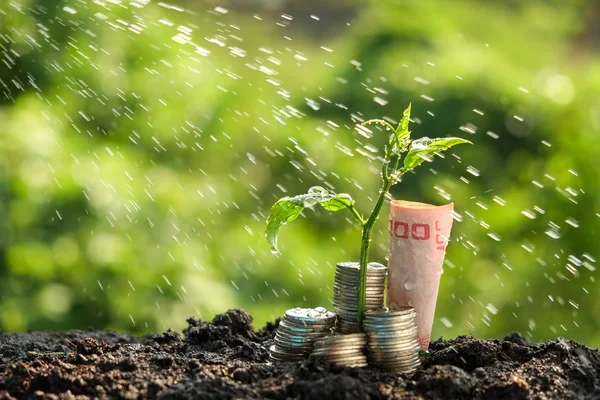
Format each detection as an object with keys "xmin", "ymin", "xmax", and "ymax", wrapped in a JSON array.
[{"xmin": 265, "ymin": 105, "xmax": 471, "ymax": 326}]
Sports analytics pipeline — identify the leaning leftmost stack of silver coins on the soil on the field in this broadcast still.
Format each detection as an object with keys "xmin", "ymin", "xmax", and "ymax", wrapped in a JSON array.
[{"xmin": 270, "ymin": 307, "xmax": 335, "ymax": 361}]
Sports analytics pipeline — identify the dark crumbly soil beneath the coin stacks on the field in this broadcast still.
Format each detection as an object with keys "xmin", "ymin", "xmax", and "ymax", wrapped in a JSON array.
[{"xmin": 0, "ymin": 310, "xmax": 600, "ymax": 400}]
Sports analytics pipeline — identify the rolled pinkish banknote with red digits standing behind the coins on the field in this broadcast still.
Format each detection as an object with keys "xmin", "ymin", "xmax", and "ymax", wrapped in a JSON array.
[{"xmin": 387, "ymin": 200, "xmax": 454, "ymax": 350}]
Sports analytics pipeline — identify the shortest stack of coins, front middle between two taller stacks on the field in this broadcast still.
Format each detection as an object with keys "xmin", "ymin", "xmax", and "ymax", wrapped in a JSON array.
[{"xmin": 310, "ymin": 333, "xmax": 367, "ymax": 368}]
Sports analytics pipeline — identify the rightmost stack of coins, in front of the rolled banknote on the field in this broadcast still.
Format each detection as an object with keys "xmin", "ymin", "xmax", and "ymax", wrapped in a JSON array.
[{"xmin": 363, "ymin": 307, "xmax": 421, "ymax": 373}]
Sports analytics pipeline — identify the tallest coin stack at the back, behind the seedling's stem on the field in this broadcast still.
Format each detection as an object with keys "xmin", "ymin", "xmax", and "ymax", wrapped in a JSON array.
[{"xmin": 333, "ymin": 262, "xmax": 387, "ymax": 333}]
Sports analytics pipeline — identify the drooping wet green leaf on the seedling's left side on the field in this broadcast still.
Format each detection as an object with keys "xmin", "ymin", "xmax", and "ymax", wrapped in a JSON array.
[{"xmin": 265, "ymin": 186, "xmax": 354, "ymax": 253}]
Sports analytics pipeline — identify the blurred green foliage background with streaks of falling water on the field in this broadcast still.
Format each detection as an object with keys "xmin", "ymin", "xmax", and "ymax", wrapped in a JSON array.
[{"xmin": 0, "ymin": 0, "xmax": 600, "ymax": 347}]
